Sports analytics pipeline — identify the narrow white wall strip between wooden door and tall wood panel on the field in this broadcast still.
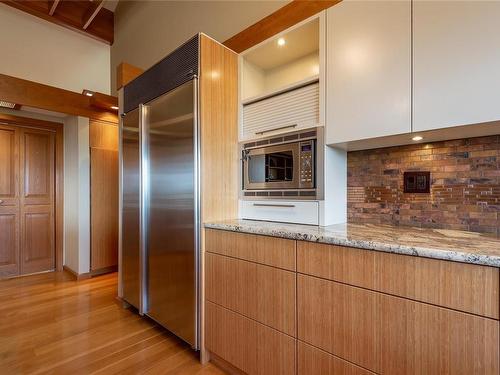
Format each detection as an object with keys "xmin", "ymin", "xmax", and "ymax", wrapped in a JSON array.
[{"xmin": 64, "ymin": 116, "xmax": 90, "ymax": 274}]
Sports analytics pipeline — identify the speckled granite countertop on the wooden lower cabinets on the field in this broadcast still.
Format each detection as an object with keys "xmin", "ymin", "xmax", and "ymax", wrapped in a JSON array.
[{"xmin": 205, "ymin": 220, "xmax": 500, "ymax": 267}]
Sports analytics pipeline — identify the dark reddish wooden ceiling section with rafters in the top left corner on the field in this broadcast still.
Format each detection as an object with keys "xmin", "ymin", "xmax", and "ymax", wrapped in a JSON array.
[{"xmin": 0, "ymin": 0, "xmax": 114, "ymax": 44}]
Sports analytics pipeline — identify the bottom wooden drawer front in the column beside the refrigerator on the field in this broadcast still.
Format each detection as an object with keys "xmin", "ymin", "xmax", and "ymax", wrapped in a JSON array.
[{"xmin": 205, "ymin": 302, "xmax": 296, "ymax": 375}]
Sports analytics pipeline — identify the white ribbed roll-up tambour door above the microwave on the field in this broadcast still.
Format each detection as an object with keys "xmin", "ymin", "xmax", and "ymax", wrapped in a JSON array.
[{"xmin": 241, "ymin": 82, "xmax": 319, "ymax": 140}]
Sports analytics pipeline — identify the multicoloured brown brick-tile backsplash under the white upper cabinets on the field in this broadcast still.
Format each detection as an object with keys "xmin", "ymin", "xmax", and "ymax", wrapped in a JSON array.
[{"xmin": 347, "ymin": 135, "xmax": 500, "ymax": 235}]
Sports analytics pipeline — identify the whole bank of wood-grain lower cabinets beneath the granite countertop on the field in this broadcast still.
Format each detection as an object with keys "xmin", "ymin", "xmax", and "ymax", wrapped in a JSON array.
[{"xmin": 205, "ymin": 230, "xmax": 500, "ymax": 375}]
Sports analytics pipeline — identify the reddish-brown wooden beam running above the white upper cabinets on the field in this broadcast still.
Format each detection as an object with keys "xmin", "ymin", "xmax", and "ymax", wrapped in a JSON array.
[{"xmin": 223, "ymin": 0, "xmax": 342, "ymax": 53}]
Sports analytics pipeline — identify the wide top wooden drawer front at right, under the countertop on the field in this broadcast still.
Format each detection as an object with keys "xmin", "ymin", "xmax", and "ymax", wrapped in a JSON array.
[{"xmin": 297, "ymin": 241, "xmax": 500, "ymax": 319}]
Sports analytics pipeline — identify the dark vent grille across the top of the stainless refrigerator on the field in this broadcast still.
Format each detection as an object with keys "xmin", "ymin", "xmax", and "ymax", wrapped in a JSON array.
[{"xmin": 123, "ymin": 35, "xmax": 199, "ymax": 113}]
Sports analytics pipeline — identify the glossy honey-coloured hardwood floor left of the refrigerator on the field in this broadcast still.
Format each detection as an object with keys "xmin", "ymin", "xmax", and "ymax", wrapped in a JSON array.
[{"xmin": 0, "ymin": 272, "xmax": 224, "ymax": 375}]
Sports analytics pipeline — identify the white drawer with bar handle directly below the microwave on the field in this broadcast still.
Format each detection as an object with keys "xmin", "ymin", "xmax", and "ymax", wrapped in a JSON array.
[{"xmin": 240, "ymin": 200, "xmax": 319, "ymax": 225}]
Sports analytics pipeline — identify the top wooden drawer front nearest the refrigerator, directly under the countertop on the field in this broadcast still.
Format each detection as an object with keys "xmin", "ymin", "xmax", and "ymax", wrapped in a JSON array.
[{"xmin": 205, "ymin": 229, "xmax": 295, "ymax": 271}]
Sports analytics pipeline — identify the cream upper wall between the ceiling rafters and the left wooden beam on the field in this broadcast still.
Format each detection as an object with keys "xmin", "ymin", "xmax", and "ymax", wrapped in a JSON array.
[{"xmin": 0, "ymin": 3, "xmax": 110, "ymax": 94}]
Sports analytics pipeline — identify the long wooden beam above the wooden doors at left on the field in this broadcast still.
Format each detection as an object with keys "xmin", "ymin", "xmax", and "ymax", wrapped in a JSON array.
[{"xmin": 0, "ymin": 74, "xmax": 118, "ymax": 123}]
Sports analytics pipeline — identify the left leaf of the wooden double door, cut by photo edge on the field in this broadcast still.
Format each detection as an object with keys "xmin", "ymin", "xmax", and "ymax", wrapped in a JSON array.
[{"xmin": 0, "ymin": 125, "xmax": 19, "ymax": 277}]
